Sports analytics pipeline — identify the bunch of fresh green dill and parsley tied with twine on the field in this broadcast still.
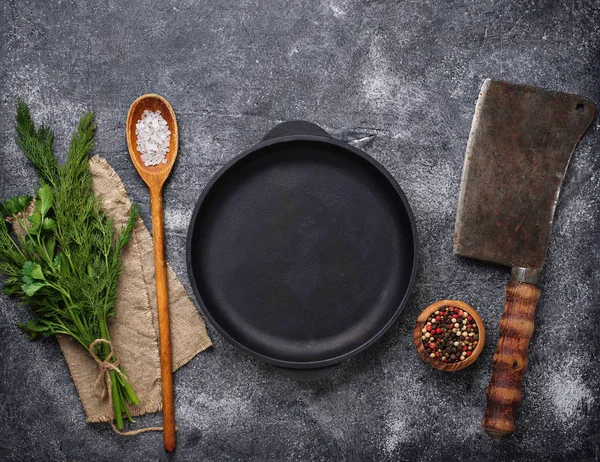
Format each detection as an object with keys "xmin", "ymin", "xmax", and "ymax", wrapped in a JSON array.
[{"xmin": 0, "ymin": 101, "xmax": 140, "ymax": 429}]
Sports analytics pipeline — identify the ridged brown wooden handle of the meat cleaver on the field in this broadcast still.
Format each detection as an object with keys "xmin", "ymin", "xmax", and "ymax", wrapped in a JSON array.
[{"xmin": 481, "ymin": 281, "xmax": 540, "ymax": 440}]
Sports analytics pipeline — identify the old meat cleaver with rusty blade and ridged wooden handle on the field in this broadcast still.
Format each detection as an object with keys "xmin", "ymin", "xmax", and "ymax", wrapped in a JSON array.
[{"xmin": 454, "ymin": 79, "xmax": 595, "ymax": 439}]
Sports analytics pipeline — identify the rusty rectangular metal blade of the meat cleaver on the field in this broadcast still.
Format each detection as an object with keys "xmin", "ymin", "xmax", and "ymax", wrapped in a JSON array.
[{"xmin": 454, "ymin": 79, "xmax": 595, "ymax": 269}]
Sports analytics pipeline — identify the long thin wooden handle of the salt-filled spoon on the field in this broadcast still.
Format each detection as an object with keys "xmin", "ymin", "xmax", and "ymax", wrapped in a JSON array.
[{"xmin": 150, "ymin": 187, "xmax": 175, "ymax": 452}]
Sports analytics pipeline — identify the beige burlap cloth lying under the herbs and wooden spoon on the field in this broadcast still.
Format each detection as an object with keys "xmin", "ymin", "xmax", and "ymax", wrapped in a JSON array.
[{"xmin": 57, "ymin": 156, "xmax": 212, "ymax": 422}]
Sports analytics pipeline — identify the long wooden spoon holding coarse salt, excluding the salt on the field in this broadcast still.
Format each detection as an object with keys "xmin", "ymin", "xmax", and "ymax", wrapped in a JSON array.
[{"xmin": 126, "ymin": 94, "xmax": 178, "ymax": 452}]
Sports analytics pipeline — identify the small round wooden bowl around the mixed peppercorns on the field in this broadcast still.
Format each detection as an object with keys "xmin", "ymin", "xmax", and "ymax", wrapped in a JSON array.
[{"xmin": 414, "ymin": 300, "xmax": 485, "ymax": 372}]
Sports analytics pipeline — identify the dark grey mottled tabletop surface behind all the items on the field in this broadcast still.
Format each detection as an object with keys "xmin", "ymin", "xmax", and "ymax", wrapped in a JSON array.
[{"xmin": 0, "ymin": 0, "xmax": 600, "ymax": 461}]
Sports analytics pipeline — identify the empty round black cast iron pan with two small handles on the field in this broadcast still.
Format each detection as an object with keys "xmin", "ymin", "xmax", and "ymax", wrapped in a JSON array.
[{"xmin": 187, "ymin": 121, "xmax": 417, "ymax": 380}]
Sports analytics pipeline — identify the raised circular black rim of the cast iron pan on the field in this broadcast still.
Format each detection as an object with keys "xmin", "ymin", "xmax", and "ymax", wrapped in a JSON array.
[{"xmin": 186, "ymin": 135, "xmax": 419, "ymax": 369}]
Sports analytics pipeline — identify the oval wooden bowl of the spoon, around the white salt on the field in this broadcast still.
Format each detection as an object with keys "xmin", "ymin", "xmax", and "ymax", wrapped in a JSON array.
[{"xmin": 126, "ymin": 93, "xmax": 179, "ymax": 187}]
